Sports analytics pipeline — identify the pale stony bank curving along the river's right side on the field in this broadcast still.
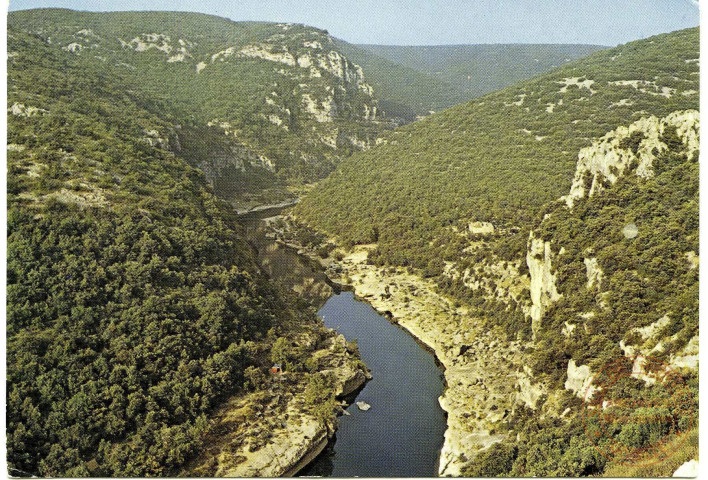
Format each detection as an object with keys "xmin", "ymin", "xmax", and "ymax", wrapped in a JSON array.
[{"xmin": 282, "ymin": 238, "xmax": 544, "ymax": 476}]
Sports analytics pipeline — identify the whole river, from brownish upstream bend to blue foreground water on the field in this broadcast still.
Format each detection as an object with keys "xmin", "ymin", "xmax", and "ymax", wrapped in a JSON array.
[{"xmin": 241, "ymin": 212, "xmax": 446, "ymax": 477}]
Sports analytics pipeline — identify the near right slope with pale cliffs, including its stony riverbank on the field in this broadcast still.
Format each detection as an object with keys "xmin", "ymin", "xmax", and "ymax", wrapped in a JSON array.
[{"xmin": 286, "ymin": 110, "xmax": 699, "ymax": 476}]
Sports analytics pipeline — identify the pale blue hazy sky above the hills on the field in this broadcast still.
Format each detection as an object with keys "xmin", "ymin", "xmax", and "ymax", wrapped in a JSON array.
[{"xmin": 10, "ymin": 0, "xmax": 699, "ymax": 45}]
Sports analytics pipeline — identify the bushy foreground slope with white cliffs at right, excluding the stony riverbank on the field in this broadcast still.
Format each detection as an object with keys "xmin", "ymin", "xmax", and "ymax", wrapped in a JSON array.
[{"xmin": 465, "ymin": 110, "xmax": 699, "ymax": 476}]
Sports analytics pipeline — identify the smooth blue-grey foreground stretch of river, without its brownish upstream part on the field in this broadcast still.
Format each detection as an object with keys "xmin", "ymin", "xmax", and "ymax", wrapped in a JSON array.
[{"xmin": 299, "ymin": 292, "xmax": 445, "ymax": 477}]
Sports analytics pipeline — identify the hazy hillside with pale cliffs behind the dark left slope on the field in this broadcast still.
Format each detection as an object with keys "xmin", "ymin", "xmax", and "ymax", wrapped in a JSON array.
[{"xmin": 8, "ymin": 9, "xmax": 382, "ymax": 208}]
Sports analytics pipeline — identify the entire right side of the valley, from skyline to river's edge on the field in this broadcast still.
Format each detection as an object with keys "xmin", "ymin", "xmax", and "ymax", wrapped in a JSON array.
[{"xmin": 296, "ymin": 29, "xmax": 699, "ymax": 476}]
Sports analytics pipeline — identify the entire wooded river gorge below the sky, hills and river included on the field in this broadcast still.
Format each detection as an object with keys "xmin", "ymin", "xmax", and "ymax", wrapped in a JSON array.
[{"xmin": 6, "ymin": 5, "xmax": 700, "ymax": 477}]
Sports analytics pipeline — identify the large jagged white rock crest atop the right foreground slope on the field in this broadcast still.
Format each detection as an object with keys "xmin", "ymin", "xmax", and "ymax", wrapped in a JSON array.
[{"xmin": 564, "ymin": 110, "xmax": 700, "ymax": 207}]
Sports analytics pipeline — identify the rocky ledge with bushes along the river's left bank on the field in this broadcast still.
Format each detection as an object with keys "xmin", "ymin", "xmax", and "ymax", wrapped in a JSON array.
[{"xmin": 184, "ymin": 334, "xmax": 370, "ymax": 477}]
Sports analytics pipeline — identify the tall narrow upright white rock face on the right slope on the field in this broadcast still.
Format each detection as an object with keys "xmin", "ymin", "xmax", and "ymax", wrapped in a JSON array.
[{"xmin": 526, "ymin": 232, "xmax": 561, "ymax": 336}]
